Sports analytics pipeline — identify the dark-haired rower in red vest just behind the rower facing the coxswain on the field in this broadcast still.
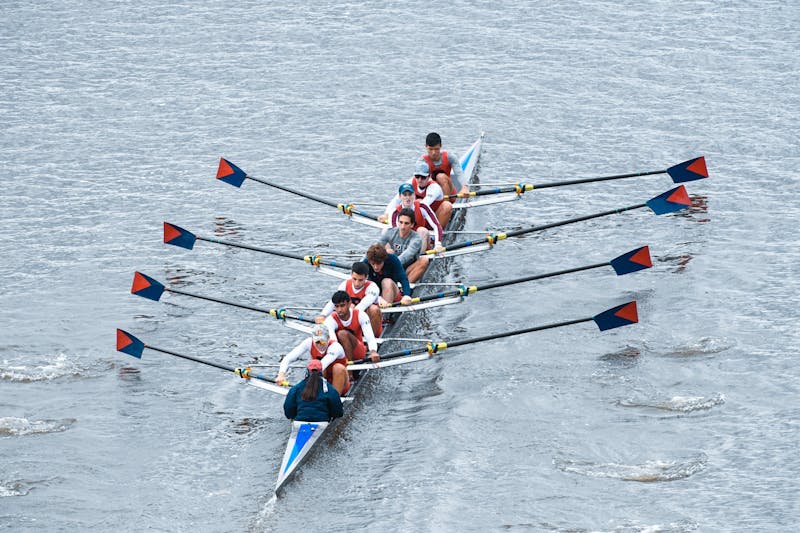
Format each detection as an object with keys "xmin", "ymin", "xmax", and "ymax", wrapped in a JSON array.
[{"xmin": 323, "ymin": 291, "xmax": 379, "ymax": 361}]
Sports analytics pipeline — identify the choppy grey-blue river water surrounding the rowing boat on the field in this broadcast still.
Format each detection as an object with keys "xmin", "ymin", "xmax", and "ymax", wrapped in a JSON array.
[{"xmin": 0, "ymin": 0, "xmax": 800, "ymax": 532}]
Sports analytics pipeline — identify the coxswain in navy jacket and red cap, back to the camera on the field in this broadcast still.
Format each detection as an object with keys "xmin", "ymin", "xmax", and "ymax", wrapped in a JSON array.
[{"xmin": 283, "ymin": 359, "xmax": 344, "ymax": 422}]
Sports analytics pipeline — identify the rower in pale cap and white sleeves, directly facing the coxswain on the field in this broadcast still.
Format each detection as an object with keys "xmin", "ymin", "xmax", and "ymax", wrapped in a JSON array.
[{"xmin": 275, "ymin": 324, "xmax": 350, "ymax": 394}]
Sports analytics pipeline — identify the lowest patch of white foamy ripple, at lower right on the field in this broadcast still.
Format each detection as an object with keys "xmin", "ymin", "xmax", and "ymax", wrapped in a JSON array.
[{"xmin": 553, "ymin": 452, "xmax": 708, "ymax": 483}]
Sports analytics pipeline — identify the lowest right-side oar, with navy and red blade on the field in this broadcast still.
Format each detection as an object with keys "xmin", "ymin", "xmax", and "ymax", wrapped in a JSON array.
[{"xmin": 348, "ymin": 301, "xmax": 639, "ymax": 370}]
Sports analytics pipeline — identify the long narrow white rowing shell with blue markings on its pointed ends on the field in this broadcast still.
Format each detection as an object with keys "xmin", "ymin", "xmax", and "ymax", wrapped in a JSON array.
[{"xmin": 275, "ymin": 134, "xmax": 483, "ymax": 494}]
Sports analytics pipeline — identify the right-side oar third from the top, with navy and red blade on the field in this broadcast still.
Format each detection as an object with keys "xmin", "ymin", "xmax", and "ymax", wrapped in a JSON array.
[{"xmin": 381, "ymin": 246, "xmax": 653, "ymax": 313}]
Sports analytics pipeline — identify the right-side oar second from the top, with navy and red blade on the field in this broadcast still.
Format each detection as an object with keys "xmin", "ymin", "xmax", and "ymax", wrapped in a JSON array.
[{"xmin": 423, "ymin": 185, "xmax": 692, "ymax": 258}]
